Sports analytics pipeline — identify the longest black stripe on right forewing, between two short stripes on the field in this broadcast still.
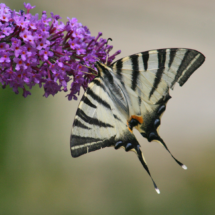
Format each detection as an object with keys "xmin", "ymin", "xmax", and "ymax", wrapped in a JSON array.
[{"xmin": 149, "ymin": 49, "xmax": 166, "ymax": 99}]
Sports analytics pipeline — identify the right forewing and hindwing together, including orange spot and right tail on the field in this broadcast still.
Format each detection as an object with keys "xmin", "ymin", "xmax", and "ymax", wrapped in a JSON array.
[{"xmin": 111, "ymin": 48, "xmax": 205, "ymax": 168}]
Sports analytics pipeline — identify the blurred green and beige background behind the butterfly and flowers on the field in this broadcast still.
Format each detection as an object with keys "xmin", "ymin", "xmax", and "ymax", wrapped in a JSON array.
[{"xmin": 0, "ymin": 0, "xmax": 215, "ymax": 215}]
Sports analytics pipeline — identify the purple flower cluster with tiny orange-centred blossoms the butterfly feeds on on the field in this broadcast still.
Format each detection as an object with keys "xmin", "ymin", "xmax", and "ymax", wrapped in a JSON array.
[{"xmin": 0, "ymin": 3, "xmax": 120, "ymax": 100}]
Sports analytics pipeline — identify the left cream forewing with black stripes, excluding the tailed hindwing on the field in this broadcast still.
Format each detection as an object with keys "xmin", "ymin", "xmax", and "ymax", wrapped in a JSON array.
[{"xmin": 70, "ymin": 78, "xmax": 116, "ymax": 157}]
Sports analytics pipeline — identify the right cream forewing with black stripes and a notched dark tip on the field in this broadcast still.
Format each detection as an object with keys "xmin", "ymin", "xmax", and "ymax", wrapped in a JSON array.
[{"xmin": 111, "ymin": 48, "xmax": 205, "ymax": 104}]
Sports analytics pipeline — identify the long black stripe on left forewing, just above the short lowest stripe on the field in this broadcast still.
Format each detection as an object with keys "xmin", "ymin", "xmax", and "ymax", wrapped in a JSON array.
[{"xmin": 76, "ymin": 108, "xmax": 114, "ymax": 128}]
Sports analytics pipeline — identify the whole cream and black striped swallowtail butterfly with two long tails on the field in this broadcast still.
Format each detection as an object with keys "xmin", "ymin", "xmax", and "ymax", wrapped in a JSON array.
[{"xmin": 70, "ymin": 48, "xmax": 205, "ymax": 193}]
